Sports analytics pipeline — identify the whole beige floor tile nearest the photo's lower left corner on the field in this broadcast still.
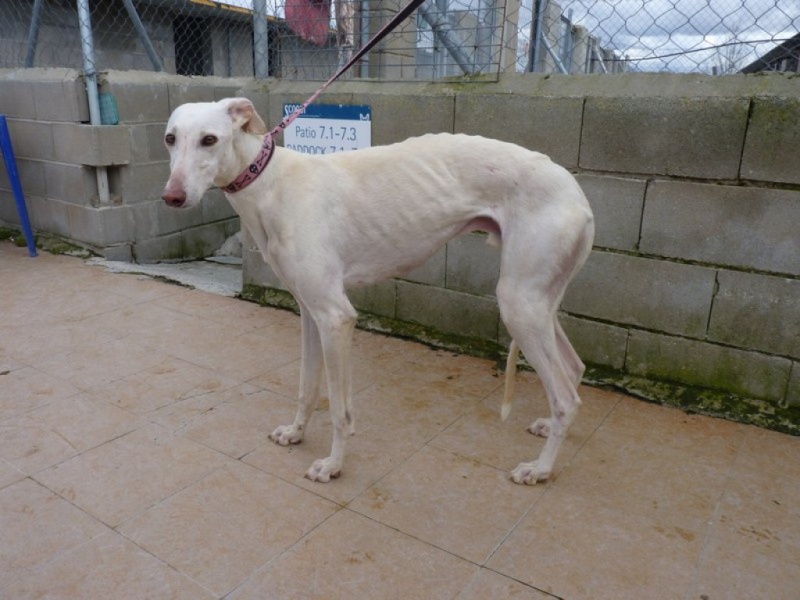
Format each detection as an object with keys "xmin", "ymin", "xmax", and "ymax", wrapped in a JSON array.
[{"xmin": 36, "ymin": 425, "xmax": 225, "ymax": 527}]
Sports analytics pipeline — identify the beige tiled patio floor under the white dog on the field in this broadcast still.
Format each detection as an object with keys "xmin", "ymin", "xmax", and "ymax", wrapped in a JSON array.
[{"xmin": 0, "ymin": 243, "xmax": 800, "ymax": 600}]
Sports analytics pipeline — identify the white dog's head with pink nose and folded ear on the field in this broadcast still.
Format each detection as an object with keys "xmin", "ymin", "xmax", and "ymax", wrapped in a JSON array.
[{"xmin": 161, "ymin": 98, "xmax": 267, "ymax": 208}]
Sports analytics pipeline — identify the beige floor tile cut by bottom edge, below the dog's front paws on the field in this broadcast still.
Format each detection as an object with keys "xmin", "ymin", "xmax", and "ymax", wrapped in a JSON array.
[{"xmin": 229, "ymin": 510, "xmax": 477, "ymax": 600}]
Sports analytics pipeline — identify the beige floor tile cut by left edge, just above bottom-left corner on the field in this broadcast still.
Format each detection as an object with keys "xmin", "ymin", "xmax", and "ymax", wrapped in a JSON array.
[{"xmin": 0, "ymin": 479, "xmax": 107, "ymax": 598}]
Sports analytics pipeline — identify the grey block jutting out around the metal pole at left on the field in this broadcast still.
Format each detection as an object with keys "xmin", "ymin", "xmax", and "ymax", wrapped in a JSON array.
[{"xmin": 52, "ymin": 123, "xmax": 131, "ymax": 166}]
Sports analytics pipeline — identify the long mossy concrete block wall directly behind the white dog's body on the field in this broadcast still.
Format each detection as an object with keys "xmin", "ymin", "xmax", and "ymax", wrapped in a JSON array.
[{"xmin": 239, "ymin": 74, "xmax": 800, "ymax": 432}]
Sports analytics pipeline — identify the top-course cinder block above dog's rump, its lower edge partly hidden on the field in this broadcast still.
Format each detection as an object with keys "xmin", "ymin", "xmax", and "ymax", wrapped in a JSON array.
[{"xmin": 454, "ymin": 94, "xmax": 583, "ymax": 168}]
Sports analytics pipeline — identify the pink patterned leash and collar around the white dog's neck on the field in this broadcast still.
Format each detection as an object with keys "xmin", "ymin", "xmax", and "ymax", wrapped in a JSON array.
[{"xmin": 222, "ymin": 0, "xmax": 425, "ymax": 194}]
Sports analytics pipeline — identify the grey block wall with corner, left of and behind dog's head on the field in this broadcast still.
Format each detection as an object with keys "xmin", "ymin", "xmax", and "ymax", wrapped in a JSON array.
[{"xmin": 0, "ymin": 69, "xmax": 245, "ymax": 262}]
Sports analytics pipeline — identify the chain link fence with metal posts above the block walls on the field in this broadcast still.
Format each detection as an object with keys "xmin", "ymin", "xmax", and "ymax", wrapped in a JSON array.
[{"xmin": 0, "ymin": 0, "xmax": 800, "ymax": 80}]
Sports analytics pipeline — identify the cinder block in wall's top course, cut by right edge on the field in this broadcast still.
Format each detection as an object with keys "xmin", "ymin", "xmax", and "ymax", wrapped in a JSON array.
[{"xmin": 741, "ymin": 94, "xmax": 800, "ymax": 183}]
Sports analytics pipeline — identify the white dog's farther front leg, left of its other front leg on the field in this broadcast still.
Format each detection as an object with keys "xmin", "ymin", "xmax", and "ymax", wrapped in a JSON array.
[{"xmin": 269, "ymin": 306, "xmax": 322, "ymax": 446}]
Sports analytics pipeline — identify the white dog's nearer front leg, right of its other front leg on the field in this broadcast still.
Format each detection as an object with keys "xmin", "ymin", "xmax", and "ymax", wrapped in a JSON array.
[{"xmin": 306, "ymin": 299, "xmax": 356, "ymax": 482}]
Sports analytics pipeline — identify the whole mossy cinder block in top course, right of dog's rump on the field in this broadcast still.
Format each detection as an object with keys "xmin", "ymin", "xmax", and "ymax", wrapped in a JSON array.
[{"xmin": 580, "ymin": 97, "xmax": 750, "ymax": 179}]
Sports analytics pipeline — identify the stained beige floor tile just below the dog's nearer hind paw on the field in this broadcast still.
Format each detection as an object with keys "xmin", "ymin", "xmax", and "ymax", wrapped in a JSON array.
[{"xmin": 487, "ymin": 484, "xmax": 703, "ymax": 600}]
